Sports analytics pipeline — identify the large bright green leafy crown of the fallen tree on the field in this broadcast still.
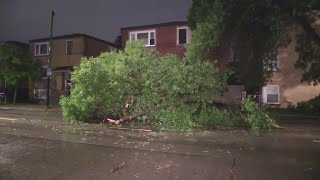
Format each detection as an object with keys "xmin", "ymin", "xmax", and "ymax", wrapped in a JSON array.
[{"xmin": 60, "ymin": 42, "xmax": 227, "ymax": 127}]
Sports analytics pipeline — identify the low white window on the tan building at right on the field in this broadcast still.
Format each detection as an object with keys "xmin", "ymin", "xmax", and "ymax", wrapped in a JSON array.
[{"xmin": 262, "ymin": 85, "xmax": 280, "ymax": 104}]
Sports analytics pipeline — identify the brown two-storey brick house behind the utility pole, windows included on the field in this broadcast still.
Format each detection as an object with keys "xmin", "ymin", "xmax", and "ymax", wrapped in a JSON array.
[{"xmin": 29, "ymin": 34, "xmax": 117, "ymax": 104}]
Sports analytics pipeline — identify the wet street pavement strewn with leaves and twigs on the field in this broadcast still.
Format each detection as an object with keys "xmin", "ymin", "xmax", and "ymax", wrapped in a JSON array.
[{"xmin": 0, "ymin": 108, "xmax": 320, "ymax": 180}]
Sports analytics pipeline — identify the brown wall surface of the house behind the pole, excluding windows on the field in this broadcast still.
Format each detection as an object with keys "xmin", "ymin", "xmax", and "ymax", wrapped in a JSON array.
[{"xmin": 30, "ymin": 35, "xmax": 116, "ymax": 104}]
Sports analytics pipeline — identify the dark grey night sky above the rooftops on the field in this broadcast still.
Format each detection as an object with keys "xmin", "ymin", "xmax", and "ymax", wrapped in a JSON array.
[{"xmin": 0, "ymin": 0, "xmax": 192, "ymax": 42}]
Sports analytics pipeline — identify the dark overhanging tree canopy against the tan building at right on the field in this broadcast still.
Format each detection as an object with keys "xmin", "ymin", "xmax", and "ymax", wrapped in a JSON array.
[{"xmin": 188, "ymin": 0, "xmax": 320, "ymax": 89}]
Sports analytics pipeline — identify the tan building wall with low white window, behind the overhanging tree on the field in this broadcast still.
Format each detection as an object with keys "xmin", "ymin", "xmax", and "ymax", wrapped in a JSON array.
[{"xmin": 262, "ymin": 31, "xmax": 320, "ymax": 108}]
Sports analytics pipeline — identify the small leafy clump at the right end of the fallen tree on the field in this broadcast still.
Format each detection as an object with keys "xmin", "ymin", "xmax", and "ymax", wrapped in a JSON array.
[{"xmin": 242, "ymin": 98, "xmax": 274, "ymax": 133}]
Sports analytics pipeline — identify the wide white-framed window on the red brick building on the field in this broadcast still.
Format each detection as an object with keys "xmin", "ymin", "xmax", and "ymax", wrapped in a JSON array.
[{"xmin": 129, "ymin": 30, "xmax": 156, "ymax": 47}]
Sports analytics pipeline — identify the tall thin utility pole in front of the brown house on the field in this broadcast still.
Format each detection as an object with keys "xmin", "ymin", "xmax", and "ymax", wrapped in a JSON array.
[{"xmin": 46, "ymin": 11, "xmax": 54, "ymax": 108}]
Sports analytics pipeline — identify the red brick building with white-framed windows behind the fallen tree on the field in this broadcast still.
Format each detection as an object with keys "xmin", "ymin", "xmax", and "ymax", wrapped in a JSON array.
[{"xmin": 121, "ymin": 22, "xmax": 244, "ymax": 100}]
